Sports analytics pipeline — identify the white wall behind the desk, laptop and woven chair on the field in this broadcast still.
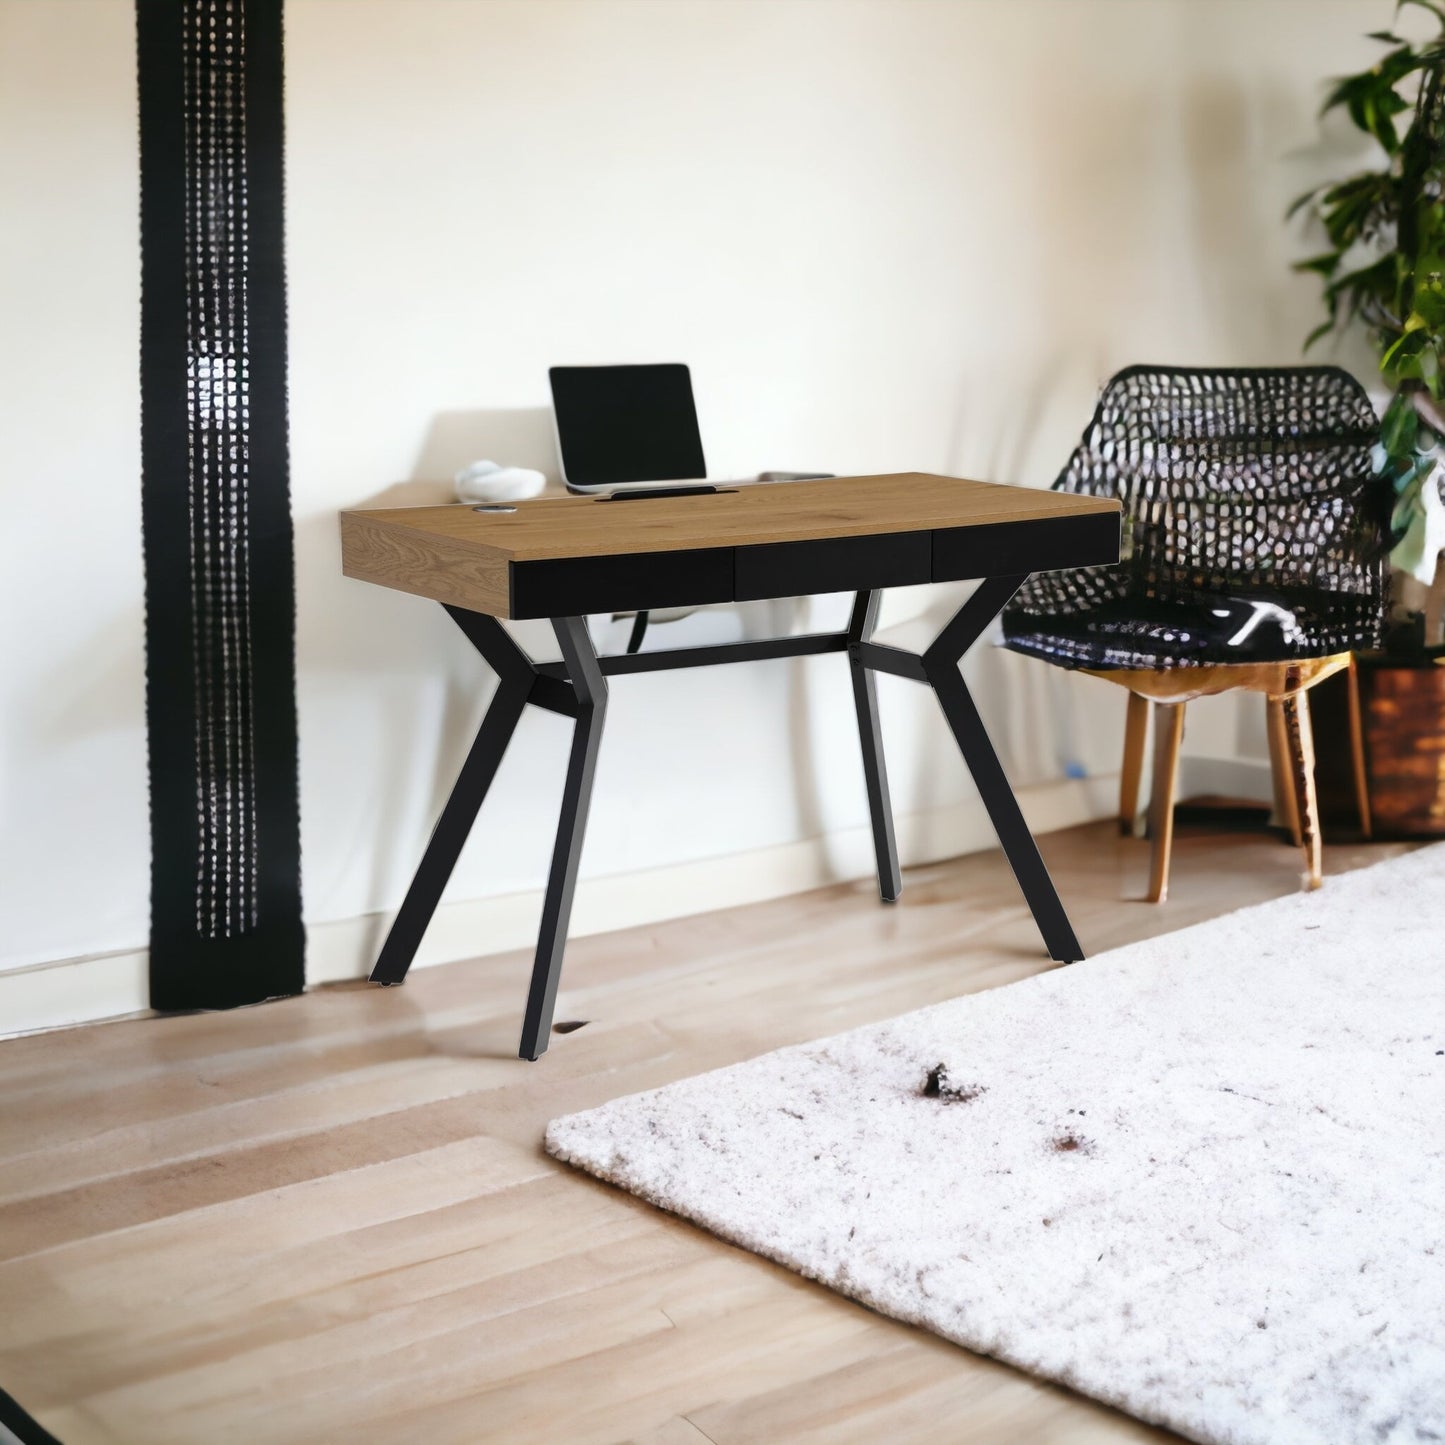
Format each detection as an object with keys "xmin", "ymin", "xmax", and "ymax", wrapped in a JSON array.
[{"xmin": 0, "ymin": 0, "xmax": 1390, "ymax": 1029}]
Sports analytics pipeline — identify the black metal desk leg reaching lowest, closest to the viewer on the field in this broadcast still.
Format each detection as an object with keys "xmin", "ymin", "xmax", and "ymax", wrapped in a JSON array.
[{"xmin": 519, "ymin": 617, "xmax": 607, "ymax": 1059}]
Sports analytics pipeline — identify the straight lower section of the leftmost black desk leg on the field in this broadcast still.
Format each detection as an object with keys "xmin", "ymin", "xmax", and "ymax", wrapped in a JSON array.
[{"xmin": 371, "ymin": 672, "xmax": 532, "ymax": 984}]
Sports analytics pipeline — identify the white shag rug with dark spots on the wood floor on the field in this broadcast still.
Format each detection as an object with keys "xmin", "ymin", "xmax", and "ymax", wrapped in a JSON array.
[{"xmin": 546, "ymin": 845, "xmax": 1445, "ymax": 1445}]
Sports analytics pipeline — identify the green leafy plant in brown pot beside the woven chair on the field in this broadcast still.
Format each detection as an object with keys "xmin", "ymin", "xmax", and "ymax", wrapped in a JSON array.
[{"xmin": 1290, "ymin": 0, "xmax": 1445, "ymax": 834}]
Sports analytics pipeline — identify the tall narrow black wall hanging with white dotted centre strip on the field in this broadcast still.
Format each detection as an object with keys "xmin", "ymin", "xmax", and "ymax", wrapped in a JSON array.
[{"xmin": 136, "ymin": 0, "xmax": 305, "ymax": 1009}]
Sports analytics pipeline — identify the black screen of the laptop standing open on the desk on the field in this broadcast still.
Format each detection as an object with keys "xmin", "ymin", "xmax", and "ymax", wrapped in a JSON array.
[{"xmin": 548, "ymin": 363, "xmax": 707, "ymax": 487}]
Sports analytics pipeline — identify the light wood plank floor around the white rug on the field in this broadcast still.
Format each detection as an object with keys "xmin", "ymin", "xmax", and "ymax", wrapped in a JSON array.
[{"xmin": 0, "ymin": 824, "xmax": 1400, "ymax": 1445}]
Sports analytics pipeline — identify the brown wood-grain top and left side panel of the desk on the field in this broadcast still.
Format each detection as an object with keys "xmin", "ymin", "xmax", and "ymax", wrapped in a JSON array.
[{"xmin": 341, "ymin": 473, "xmax": 1120, "ymax": 617}]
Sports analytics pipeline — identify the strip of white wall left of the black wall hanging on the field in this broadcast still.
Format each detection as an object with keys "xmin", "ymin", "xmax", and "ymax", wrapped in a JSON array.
[{"xmin": 0, "ymin": 0, "xmax": 150, "ymax": 994}]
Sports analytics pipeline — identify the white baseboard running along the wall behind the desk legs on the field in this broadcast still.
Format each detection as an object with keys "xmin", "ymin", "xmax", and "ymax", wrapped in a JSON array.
[{"xmin": 0, "ymin": 773, "xmax": 1115, "ymax": 1038}]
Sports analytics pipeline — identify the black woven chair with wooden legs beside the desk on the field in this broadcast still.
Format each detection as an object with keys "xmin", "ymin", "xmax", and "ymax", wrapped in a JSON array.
[{"xmin": 1003, "ymin": 366, "xmax": 1389, "ymax": 902}]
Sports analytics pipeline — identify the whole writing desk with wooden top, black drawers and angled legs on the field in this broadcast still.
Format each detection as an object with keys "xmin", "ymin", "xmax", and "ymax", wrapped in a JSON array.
[{"xmin": 341, "ymin": 473, "xmax": 1120, "ymax": 1059}]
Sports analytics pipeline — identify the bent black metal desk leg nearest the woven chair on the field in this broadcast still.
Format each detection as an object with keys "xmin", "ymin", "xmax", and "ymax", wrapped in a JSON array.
[{"xmin": 923, "ymin": 577, "xmax": 1084, "ymax": 964}]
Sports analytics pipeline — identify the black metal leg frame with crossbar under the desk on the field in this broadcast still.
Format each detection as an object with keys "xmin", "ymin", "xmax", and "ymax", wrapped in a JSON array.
[{"xmin": 371, "ymin": 575, "xmax": 1084, "ymax": 1059}]
